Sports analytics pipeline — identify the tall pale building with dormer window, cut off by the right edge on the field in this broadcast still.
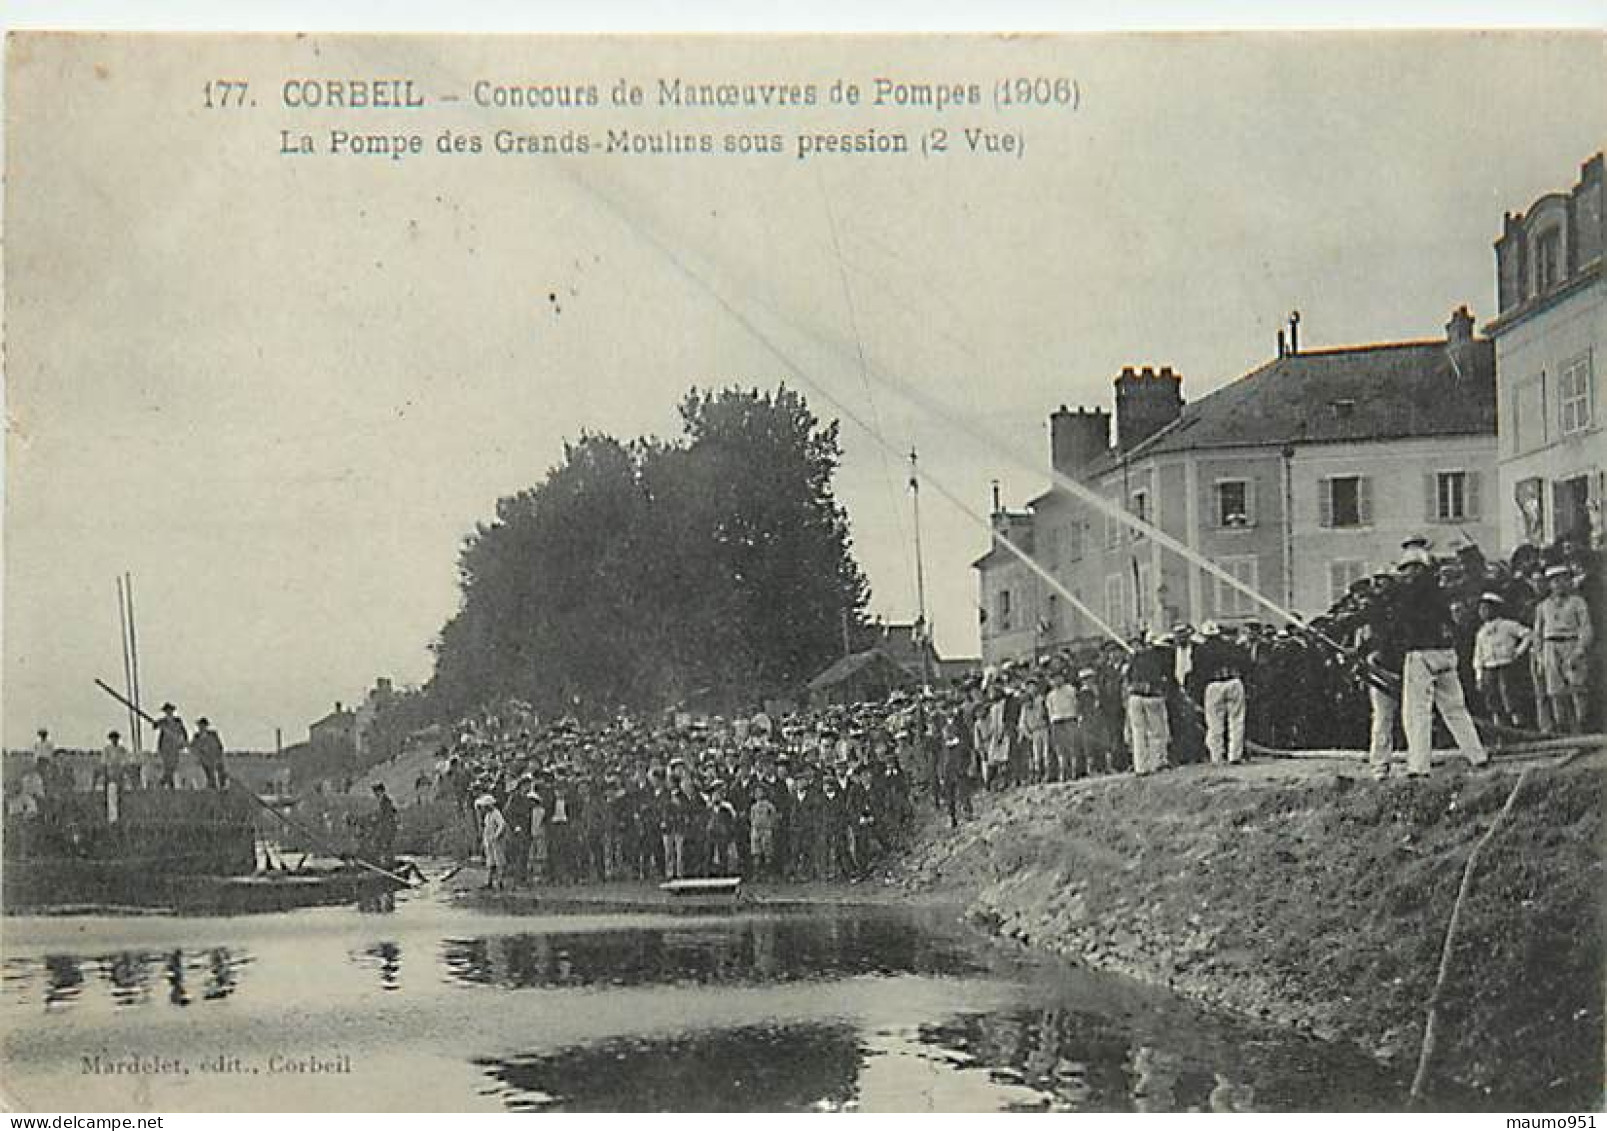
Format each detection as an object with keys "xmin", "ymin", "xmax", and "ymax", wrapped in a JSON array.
[{"xmin": 1485, "ymin": 153, "xmax": 1607, "ymax": 549}]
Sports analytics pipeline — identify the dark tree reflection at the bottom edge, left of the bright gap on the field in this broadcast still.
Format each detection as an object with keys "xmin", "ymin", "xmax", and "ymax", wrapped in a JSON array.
[{"xmin": 476, "ymin": 1023, "xmax": 861, "ymax": 1112}]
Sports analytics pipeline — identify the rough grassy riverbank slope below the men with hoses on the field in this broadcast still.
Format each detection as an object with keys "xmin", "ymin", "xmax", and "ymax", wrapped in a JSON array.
[{"xmin": 895, "ymin": 750, "xmax": 1607, "ymax": 1110}]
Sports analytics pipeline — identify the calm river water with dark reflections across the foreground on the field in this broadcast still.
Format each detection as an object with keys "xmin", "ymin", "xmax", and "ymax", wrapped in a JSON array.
[{"xmin": 0, "ymin": 895, "xmax": 1400, "ymax": 1112}]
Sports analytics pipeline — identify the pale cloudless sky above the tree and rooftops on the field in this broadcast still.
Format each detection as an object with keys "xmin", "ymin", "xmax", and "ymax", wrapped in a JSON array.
[{"xmin": 0, "ymin": 34, "xmax": 1607, "ymax": 749}]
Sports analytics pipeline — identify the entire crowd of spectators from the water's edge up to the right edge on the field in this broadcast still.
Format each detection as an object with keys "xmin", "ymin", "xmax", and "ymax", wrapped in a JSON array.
[{"xmin": 419, "ymin": 526, "xmax": 1607, "ymax": 887}]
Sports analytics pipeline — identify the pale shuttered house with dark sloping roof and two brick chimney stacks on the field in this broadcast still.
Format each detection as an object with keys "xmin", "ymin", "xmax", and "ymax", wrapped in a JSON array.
[{"xmin": 972, "ymin": 307, "xmax": 1496, "ymax": 663}]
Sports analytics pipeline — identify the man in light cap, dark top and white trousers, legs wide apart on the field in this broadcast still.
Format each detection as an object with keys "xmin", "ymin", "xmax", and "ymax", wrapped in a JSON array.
[{"xmin": 1390, "ymin": 546, "xmax": 1490, "ymax": 778}]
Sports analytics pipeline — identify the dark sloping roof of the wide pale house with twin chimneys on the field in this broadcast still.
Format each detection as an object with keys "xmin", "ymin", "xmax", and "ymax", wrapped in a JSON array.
[{"xmin": 1083, "ymin": 337, "xmax": 1496, "ymax": 479}]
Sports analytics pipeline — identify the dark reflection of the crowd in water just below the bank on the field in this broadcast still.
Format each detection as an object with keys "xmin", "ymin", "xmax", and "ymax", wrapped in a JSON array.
[{"xmin": 442, "ymin": 916, "xmax": 983, "ymax": 990}]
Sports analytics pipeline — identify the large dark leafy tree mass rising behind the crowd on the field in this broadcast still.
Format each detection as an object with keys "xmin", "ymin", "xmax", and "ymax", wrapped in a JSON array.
[{"xmin": 429, "ymin": 384, "xmax": 868, "ymax": 715}]
